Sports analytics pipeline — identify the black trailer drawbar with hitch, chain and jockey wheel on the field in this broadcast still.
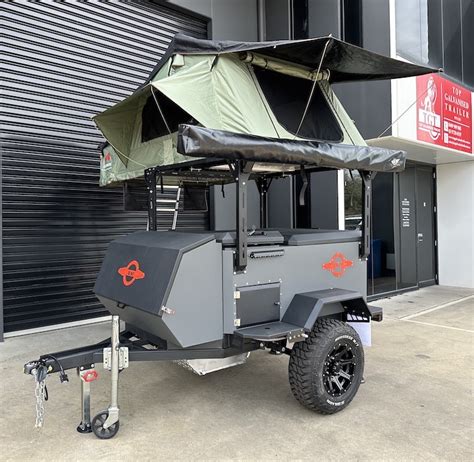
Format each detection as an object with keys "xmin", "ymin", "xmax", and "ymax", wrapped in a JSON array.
[{"xmin": 24, "ymin": 316, "xmax": 262, "ymax": 439}]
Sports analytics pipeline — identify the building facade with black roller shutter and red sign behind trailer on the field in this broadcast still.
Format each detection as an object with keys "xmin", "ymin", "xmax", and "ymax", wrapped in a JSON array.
[{"xmin": 0, "ymin": 0, "xmax": 474, "ymax": 337}]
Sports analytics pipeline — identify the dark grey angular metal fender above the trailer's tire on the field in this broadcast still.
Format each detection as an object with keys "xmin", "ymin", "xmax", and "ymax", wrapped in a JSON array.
[{"xmin": 282, "ymin": 288, "xmax": 371, "ymax": 331}]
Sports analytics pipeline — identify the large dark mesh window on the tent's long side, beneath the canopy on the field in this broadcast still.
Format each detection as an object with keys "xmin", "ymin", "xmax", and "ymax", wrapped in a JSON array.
[{"xmin": 253, "ymin": 67, "xmax": 343, "ymax": 142}]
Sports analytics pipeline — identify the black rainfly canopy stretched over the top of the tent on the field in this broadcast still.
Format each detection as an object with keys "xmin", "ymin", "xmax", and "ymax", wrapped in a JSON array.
[{"xmin": 147, "ymin": 34, "xmax": 439, "ymax": 83}]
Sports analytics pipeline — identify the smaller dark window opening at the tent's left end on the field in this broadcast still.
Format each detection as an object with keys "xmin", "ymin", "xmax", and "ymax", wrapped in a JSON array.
[{"xmin": 142, "ymin": 91, "xmax": 194, "ymax": 143}]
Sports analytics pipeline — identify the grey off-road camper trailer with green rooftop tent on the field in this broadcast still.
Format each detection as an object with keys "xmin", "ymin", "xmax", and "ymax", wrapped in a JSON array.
[{"xmin": 25, "ymin": 35, "xmax": 433, "ymax": 439}]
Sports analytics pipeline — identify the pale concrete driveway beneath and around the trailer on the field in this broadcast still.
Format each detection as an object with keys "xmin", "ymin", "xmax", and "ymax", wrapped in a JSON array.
[{"xmin": 0, "ymin": 287, "xmax": 474, "ymax": 461}]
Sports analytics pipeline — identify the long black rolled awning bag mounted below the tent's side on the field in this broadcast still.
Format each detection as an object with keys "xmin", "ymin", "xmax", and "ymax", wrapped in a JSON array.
[{"xmin": 177, "ymin": 124, "xmax": 406, "ymax": 172}]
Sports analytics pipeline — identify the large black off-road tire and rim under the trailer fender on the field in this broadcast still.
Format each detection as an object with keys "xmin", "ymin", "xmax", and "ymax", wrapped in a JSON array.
[{"xmin": 288, "ymin": 319, "xmax": 364, "ymax": 414}]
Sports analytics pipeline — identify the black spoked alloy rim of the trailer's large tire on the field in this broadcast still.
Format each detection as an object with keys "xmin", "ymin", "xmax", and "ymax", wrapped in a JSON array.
[{"xmin": 323, "ymin": 342, "xmax": 357, "ymax": 397}]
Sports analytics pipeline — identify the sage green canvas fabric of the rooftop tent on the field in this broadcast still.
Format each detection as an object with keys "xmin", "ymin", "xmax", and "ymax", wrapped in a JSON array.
[{"xmin": 94, "ymin": 54, "xmax": 365, "ymax": 186}]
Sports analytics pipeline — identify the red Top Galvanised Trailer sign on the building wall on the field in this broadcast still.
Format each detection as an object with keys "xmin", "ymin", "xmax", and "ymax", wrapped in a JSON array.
[{"xmin": 416, "ymin": 74, "xmax": 472, "ymax": 154}]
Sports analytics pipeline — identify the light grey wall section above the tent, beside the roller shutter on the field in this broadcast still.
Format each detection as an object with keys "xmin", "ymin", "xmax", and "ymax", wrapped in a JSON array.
[{"xmin": 168, "ymin": 0, "xmax": 258, "ymax": 41}]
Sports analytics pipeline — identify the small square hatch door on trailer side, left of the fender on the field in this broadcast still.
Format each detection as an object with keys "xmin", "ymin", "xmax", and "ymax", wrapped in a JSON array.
[{"xmin": 236, "ymin": 282, "xmax": 280, "ymax": 327}]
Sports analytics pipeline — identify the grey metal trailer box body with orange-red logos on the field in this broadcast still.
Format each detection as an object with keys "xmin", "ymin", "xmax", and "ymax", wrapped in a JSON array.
[{"xmin": 95, "ymin": 230, "xmax": 366, "ymax": 348}]
